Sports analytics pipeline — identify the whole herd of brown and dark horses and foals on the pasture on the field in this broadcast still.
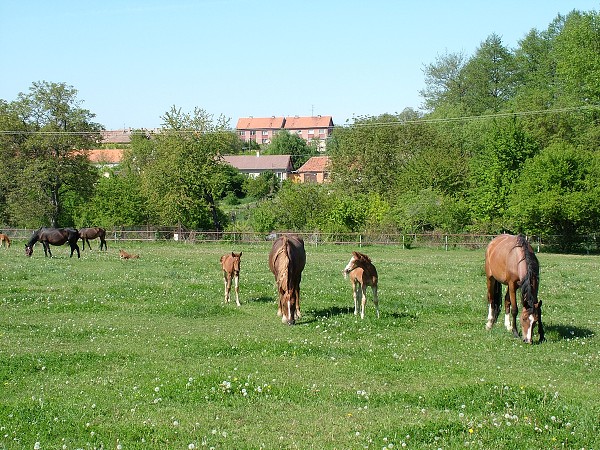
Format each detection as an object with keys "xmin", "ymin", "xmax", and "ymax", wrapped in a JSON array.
[{"xmin": 8, "ymin": 227, "xmax": 544, "ymax": 343}]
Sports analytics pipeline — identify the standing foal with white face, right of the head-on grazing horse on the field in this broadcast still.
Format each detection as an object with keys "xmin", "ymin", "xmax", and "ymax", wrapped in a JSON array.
[{"xmin": 342, "ymin": 252, "xmax": 379, "ymax": 319}]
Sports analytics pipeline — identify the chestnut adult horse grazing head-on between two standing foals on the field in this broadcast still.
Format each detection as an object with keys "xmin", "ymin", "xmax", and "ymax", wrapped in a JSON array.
[{"xmin": 269, "ymin": 235, "xmax": 306, "ymax": 325}]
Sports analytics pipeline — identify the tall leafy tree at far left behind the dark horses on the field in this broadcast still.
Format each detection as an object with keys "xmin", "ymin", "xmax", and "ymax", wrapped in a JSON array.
[{"xmin": 3, "ymin": 81, "xmax": 101, "ymax": 227}]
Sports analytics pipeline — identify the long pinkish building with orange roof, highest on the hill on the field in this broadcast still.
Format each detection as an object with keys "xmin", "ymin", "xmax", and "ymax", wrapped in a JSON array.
[{"xmin": 236, "ymin": 116, "xmax": 333, "ymax": 149}]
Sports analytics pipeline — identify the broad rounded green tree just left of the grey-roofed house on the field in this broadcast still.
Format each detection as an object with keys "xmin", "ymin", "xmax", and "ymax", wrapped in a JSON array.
[{"xmin": 134, "ymin": 107, "xmax": 241, "ymax": 230}]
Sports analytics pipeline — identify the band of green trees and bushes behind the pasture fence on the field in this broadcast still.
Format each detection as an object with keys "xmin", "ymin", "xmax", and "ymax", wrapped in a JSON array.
[{"xmin": 0, "ymin": 11, "xmax": 600, "ymax": 253}]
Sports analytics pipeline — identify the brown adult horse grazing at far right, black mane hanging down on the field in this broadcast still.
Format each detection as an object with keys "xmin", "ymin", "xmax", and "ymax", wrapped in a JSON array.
[{"xmin": 485, "ymin": 234, "xmax": 544, "ymax": 343}]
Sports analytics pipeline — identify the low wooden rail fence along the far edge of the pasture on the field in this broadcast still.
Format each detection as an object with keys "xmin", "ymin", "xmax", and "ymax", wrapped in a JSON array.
[{"xmin": 2, "ymin": 227, "xmax": 600, "ymax": 253}]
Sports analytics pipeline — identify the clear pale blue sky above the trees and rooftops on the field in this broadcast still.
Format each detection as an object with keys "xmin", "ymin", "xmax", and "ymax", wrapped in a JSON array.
[{"xmin": 0, "ymin": 0, "xmax": 600, "ymax": 129}]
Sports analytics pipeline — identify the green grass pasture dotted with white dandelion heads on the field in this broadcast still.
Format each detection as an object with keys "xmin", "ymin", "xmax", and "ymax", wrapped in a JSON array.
[{"xmin": 0, "ymin": 241, "xmax": 600, "ymax": 449}]
